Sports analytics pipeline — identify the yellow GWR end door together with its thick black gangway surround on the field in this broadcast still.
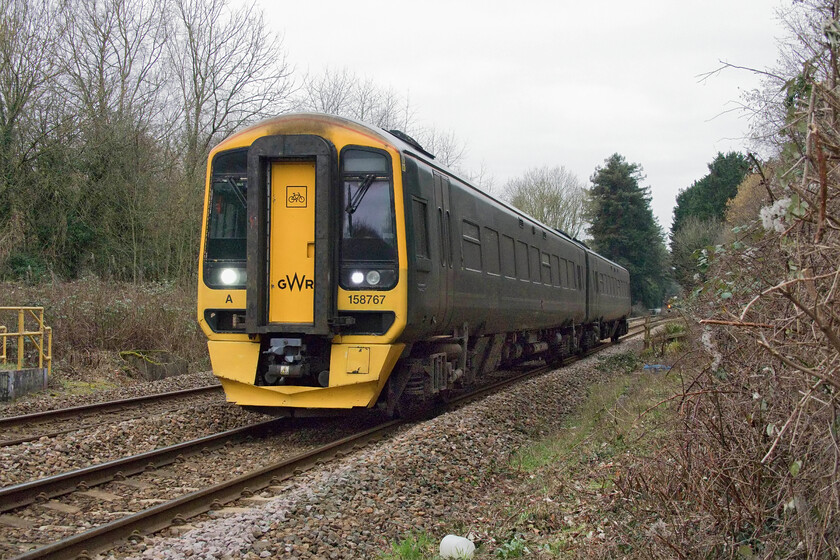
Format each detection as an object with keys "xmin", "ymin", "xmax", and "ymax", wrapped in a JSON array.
[{"xmin": 245, "ymin": 134, "xmax": 338, "ymax": 335}]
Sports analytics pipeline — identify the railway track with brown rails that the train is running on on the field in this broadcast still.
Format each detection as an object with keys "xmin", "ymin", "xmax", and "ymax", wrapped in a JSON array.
[{"xmin": 0, "ymin": 334, "xmax": 632, "ymax": 560}]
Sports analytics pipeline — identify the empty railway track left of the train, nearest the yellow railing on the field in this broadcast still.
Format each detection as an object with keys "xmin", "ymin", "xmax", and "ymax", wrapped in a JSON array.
[{"xmin": 0, "ymin": 385, "xmax": 222, "ymax": 447}]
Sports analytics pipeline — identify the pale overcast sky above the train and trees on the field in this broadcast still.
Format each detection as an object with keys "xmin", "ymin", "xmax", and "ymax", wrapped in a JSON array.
[{"xmin": 259, "ymin": 0, "xmax": 790, "ymax": 230}]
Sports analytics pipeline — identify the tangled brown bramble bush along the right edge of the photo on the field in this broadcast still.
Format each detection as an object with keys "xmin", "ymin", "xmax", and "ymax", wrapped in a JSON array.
[{"xmin": 605, "ymin": 0, "xmax": 840, "ymax": 559}]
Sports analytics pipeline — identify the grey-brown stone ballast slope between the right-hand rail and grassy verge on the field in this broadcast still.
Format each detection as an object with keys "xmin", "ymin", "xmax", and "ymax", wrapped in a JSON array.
[{"xmin": 99, "ymin": 343, "xmax": 638, "ymax": 560}]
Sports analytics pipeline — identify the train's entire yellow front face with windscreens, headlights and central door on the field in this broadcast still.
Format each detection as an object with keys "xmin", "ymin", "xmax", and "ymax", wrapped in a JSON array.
[{"xmin": 199, "ymin": 122, "xmax": 406, "ymax": 409}]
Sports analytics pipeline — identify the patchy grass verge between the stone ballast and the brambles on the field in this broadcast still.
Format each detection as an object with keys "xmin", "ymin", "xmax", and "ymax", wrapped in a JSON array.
[{"xmin": 496, "ymin": 353, "xmax": 680, "ymax": 558}]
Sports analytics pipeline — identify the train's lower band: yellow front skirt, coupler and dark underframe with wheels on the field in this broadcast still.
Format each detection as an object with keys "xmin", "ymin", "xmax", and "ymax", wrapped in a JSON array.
[{"xmin": 220, "ymin": 318, "xmax": 628, "ymax": 415}]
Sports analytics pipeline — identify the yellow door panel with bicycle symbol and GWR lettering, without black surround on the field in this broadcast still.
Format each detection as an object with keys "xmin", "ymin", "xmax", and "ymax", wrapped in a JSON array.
[{"xmin": 268, "ymin": 161, "xmax": 315, "ymax": 324}]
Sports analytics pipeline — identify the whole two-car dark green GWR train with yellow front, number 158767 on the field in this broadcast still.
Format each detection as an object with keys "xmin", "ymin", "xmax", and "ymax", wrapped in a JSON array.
[{"xmin": 198, "ymin": 113, "xmax": 631, "ymax": 415}]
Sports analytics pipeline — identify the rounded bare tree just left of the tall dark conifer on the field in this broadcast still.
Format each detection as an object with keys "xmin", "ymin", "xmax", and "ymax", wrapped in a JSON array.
[{"xmin": 502, "ymin": 166, "xmax": 586, "ymax": 237}]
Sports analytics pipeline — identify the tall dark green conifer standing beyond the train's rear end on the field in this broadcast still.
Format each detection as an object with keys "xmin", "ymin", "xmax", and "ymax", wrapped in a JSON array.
[{"xmin": 589, "ymin": 154, "xmax": 668, "ymax": 307}]
